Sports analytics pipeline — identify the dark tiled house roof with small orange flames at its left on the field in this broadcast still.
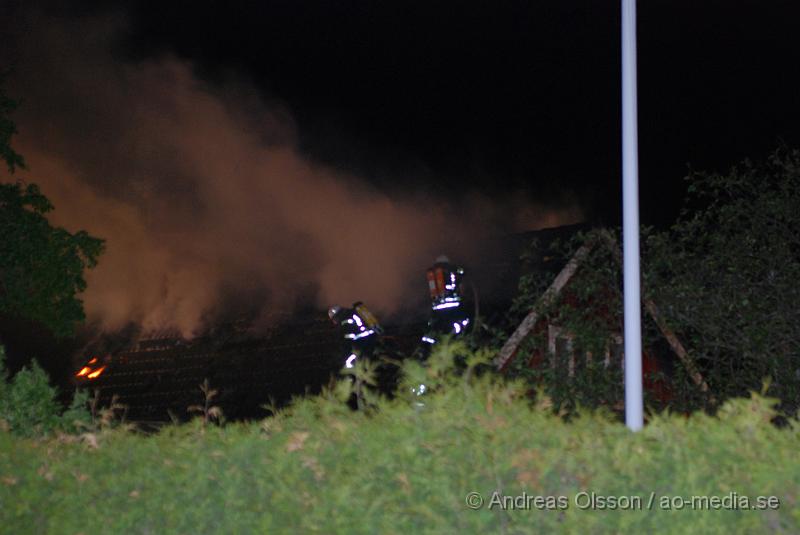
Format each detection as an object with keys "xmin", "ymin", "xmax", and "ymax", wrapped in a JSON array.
[{"xmin": 74, "ymin": 227, "xmax": 588, "ymax": 421}]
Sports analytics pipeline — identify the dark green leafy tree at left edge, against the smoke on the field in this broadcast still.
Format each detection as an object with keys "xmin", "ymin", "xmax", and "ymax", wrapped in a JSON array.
[{"xmin": 0, "ymin": 80, "xmax": 104, "ymax": 336}]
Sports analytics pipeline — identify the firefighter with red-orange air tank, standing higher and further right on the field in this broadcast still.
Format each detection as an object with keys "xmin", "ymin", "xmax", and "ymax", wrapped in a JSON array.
[{"xmin": 422, "ymin": 255, "xmax": 471, "ymax": 353}]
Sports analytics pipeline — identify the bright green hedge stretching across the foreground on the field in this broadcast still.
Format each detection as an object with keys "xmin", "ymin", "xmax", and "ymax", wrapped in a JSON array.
[{"xmin": 0, "ymin": 346, "xmax": 800, "ymax": 533}]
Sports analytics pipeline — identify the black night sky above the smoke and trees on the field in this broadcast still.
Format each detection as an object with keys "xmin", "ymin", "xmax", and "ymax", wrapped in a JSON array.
[{"xmin": 115, "ymin": 0, "xmax": 800, "ymax": 223}]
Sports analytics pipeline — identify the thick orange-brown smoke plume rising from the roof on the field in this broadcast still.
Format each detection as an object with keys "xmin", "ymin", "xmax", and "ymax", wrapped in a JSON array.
[{"xmin": 2, "ymin": 10, "xmax": 580, "ymax": 335}]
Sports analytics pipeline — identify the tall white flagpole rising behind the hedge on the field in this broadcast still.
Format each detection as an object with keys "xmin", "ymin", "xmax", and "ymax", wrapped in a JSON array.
[{"xmin": 622, "ymin": 0, "xmax": 644, "ymax": 431}]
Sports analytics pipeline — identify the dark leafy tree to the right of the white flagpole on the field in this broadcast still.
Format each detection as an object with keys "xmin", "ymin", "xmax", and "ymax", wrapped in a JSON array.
[{"xmin": 644, "ymin": 148, "xmax": 800, "ymax": 412}]
